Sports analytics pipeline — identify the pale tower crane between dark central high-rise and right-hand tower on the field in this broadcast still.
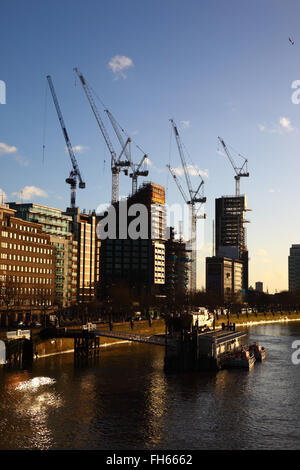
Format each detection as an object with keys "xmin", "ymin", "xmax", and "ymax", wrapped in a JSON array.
[{"xmin": 167, "ymin": 119, "xmax": 206, "ymax": 292}]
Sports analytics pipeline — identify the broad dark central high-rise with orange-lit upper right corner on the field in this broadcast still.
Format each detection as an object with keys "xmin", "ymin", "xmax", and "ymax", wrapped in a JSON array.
[{"xmin": 98, "ymin": 182, "xmax": 166, "ymax": 296}]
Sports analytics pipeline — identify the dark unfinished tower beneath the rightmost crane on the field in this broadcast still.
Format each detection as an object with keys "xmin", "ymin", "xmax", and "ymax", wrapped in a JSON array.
[{"xmin": 215, "ymin": 195, "xmax": 249, "ymax": 294}]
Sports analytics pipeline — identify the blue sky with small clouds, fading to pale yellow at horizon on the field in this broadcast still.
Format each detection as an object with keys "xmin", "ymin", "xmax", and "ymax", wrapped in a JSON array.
[{"xmin": 0, "ymin": 0, "xmax": 300, "ymax": 292}]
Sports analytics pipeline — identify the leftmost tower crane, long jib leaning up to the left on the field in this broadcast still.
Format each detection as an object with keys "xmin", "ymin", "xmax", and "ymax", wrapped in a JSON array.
[{"xmin": 47, "ymin": 75, "xmax": 85, "ymax": 209}]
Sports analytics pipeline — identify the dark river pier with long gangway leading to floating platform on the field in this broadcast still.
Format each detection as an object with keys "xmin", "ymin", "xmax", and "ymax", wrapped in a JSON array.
[{"xmin": 1, "ymin": 324, "xmax": 246, "ymax": 372}]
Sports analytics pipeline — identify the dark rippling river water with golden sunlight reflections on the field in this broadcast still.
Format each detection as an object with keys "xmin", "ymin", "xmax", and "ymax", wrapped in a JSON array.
[{"xmin": 0, "ymin": 322, "xmax": 300, "ymax": 450}]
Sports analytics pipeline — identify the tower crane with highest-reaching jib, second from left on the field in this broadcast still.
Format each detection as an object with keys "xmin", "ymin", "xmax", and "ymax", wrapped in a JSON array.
[{"xmin": 74, "ymin": 68, "xmax": 131, "ymax": 203}]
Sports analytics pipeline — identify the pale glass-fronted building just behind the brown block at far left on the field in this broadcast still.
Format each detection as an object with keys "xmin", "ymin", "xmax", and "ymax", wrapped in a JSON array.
[{"xmin": 9, "ymin": 202, "xmax": 77, "ymax": 307}]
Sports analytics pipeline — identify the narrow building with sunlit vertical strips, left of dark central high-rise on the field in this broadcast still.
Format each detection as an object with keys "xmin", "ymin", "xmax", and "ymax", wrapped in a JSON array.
[{"xmin": 66, "ymin": 208, "xmax": 101, "ymax": 302}]
